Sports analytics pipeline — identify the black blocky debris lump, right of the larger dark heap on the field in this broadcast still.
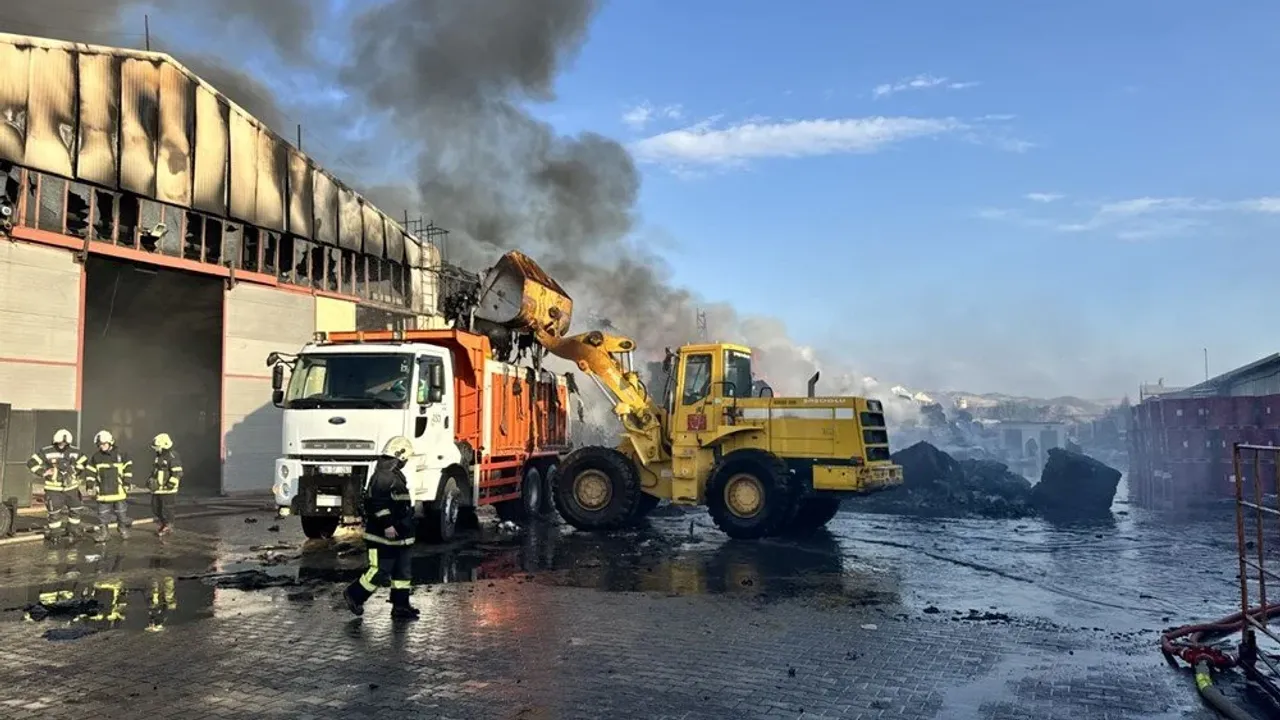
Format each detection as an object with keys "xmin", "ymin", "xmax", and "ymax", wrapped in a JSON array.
[{"xmin": 1032, "ymin": 447, "xmax": 1120, "ymax": 520}]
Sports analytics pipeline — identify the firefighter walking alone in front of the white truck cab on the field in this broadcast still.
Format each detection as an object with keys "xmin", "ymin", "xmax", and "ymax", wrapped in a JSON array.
[{"xmin": 343, "ymin": 437, "xmax": 419, "ymax": 620}]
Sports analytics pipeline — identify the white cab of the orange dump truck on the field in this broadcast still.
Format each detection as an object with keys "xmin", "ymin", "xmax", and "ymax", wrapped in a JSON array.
[{"xmin": 269, "ymin": 341, "xmax": 463, "ymax": 538}]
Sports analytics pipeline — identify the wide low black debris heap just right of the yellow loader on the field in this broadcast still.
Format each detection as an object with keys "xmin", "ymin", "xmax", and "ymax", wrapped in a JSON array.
[{"xmin": 846, "ymin": 442, "xmax": 1036, "ymax": 518}]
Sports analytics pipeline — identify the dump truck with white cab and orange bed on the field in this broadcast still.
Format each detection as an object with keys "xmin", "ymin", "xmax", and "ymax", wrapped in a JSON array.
[{"xmin": 268, "ymin": 329, "xmax": 572, "ymax": 542}]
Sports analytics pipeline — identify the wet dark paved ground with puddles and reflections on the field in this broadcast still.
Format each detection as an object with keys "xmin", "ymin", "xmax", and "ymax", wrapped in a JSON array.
[{"xmin": 0, "ymin": 481, "xmax": 1280, "ymax": 720}]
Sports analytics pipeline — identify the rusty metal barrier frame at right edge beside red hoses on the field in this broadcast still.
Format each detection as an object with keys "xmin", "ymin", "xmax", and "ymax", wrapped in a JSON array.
[{"xmin": 1231, "ymin": 443, "xmax": 1280, "ymax": 702}]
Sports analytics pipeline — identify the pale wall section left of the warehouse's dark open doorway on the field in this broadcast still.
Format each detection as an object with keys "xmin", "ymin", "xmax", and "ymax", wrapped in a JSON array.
[{"xmin": 0, "ymin": 241, "xmax": 82, "ymax": 410}]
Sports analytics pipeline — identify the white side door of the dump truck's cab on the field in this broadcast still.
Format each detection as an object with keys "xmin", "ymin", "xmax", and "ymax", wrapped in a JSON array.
[{"xmin": 406, "ymin": 350, "xmax": 457, "ymax": 481}]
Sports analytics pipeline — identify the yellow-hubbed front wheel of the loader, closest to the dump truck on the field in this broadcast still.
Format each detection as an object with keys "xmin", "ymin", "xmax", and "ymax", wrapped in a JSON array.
[{"xmin": 552, "ymin": 446, "xmax": 644, "ymax": 530}]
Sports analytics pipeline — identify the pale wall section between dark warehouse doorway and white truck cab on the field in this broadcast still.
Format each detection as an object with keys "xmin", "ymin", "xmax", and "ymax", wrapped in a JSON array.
[{"xmin": 223, "ymin": 283, "xmax": 316, "ymax": 493}]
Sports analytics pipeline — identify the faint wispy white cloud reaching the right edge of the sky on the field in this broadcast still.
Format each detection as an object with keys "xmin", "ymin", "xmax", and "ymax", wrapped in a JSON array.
[{"xmin": 977, "ymin": 192, "xmax": 1280, "ymax": 240}]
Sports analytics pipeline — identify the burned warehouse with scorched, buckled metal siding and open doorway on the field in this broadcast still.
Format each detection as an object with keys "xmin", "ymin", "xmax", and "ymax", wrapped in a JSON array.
[{"xmin": 0, "ymin": 33, "xmax": 450, "ymax": 503}]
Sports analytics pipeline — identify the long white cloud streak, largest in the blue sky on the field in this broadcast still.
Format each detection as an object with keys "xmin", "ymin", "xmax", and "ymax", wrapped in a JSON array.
[{"xmin": 631, "ymin": 117, "xmax": 966, "ymax": 165}]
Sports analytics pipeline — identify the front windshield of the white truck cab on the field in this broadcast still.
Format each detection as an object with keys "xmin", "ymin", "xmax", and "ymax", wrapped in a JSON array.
[{"xmin": 284, "ymin": 352, "xmax": 413, "ymax": 410}]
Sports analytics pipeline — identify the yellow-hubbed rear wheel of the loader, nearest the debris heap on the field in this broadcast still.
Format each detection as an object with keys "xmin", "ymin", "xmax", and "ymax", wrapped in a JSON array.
[{"xmin": 707, "ymin": 448, "xmax": 796, "ymax": 539}]
